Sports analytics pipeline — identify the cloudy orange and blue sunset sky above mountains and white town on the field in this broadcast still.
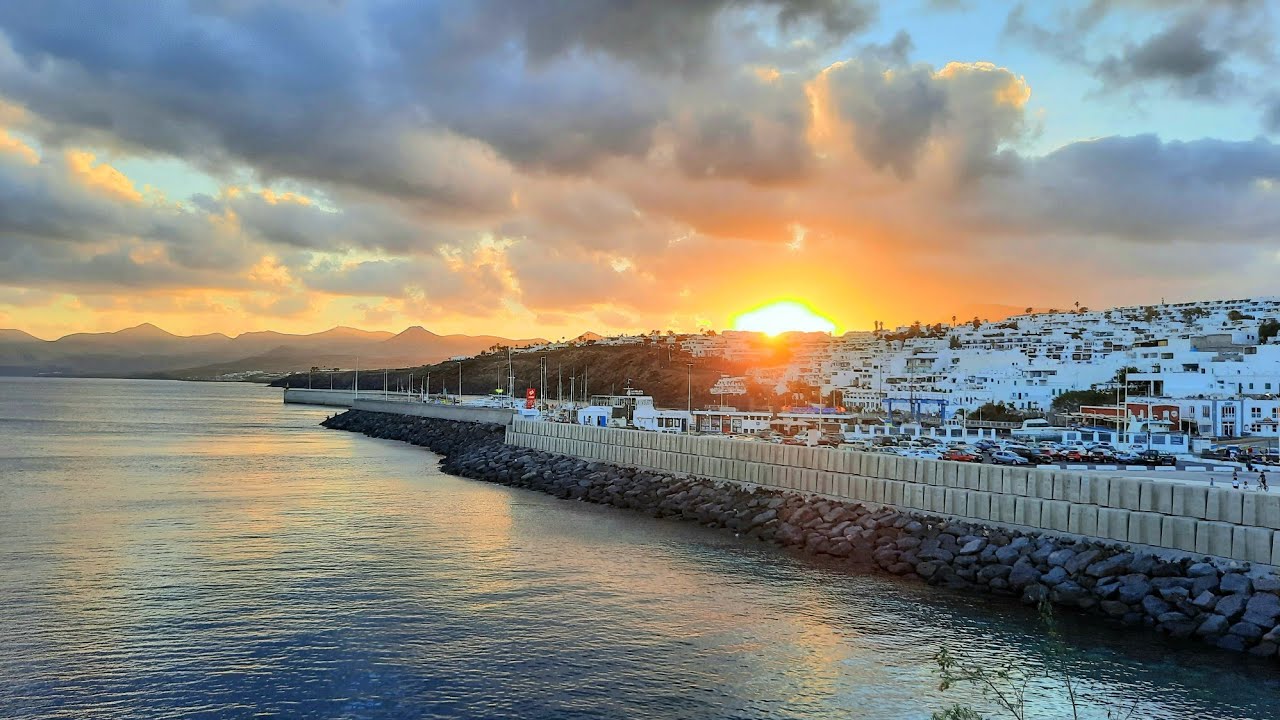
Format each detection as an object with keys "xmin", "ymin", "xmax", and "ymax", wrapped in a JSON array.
[{"xmin": 0, "ymin": 0, "xmax": 1280, "ymax": 338}]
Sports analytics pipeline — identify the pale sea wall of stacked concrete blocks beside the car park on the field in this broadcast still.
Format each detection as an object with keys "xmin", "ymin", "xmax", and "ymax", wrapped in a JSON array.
[{"xmin": 507, "ymin": 420, "xmax": 1280, "ymax": 565}]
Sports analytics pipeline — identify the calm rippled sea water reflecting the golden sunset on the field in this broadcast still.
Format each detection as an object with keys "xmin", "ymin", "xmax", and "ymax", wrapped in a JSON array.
[{"xmin": 0, "ymin": 378, "xmax": 1280, "ymax": 719}]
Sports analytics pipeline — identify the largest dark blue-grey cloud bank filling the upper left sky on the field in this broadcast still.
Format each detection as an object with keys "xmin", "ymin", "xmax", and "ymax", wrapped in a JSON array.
[{"xmin": 0, "ymin": 0, "xmax": 873, "ymax": 185}]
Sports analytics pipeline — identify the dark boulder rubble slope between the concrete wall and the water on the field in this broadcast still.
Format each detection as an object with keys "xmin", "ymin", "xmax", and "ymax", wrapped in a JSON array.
[{"xmin": 324, "ymin": 411, "xmax": 1280, "ymax": 657}]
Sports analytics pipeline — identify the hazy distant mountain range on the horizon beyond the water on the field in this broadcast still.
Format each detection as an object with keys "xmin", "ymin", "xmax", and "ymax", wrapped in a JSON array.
[{"xmin": 0, "ymin": 323, "xmax": 545, "ymax": 379}]
